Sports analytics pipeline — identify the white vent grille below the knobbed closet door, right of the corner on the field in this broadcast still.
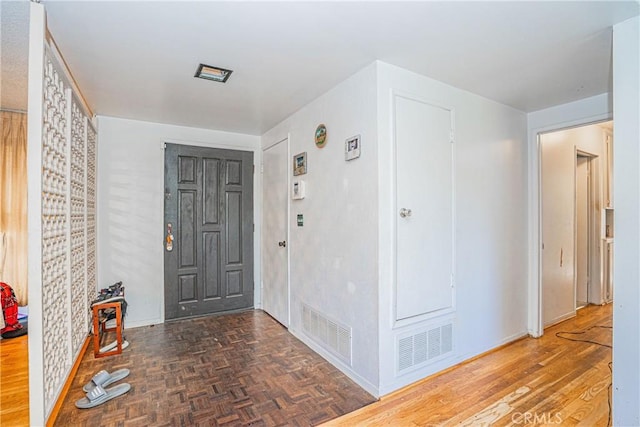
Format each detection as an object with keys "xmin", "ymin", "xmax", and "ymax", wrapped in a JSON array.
[{"xmin": 397, "ymin": 323, "xmax": 453, "ymax": 373}]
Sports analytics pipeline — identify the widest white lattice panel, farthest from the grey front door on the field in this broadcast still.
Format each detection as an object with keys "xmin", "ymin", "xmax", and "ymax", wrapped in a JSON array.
[{"xmin": 42, "ymin": 52, "xmax": 71, "ymax": 407}]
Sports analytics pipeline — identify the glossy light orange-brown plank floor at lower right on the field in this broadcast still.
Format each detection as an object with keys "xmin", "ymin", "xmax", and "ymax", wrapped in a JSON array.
[{"xmin": 324, "ymin": 304, "xmax": 613, "ymax": 427}]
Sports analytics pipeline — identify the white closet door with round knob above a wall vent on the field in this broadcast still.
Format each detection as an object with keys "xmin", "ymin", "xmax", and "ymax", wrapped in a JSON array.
[{"xmin": 395, "ymin": 96, "xmax": 454, "ymax": 320}]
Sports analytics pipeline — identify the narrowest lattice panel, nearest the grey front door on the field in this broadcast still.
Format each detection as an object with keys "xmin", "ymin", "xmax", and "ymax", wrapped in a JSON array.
[{"xmin": 86, "ymin": 125, "xmax": 98, "ymax": 314}]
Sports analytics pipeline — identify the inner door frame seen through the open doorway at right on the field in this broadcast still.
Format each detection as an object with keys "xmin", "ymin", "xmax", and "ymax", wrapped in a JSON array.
[{"xmin": 573, "ymin": 148, "xmax": 604, "ymax": 310}]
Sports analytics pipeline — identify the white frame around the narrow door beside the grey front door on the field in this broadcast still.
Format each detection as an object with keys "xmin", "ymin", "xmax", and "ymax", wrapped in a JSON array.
[{"xmin": 254, "ymin": 133, "xmax": 292, "ymax": 329}]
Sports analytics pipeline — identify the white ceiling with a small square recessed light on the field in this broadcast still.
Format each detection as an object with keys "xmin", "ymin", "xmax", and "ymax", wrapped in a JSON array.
[{"xmin": 2, "ymin": 0, "xmax": 639, "ymax": 135}]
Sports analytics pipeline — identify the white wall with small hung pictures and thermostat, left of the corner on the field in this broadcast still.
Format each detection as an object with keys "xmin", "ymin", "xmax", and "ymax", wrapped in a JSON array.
[{"xmin": 262, "ymin": 64, "xmax": 378, "ymax": 394}]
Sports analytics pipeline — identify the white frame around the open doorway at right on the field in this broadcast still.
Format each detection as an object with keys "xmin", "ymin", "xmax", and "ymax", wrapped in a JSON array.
[{"xmin": 527, "ymin": 117, "xmax": 614, "ymax": 338}]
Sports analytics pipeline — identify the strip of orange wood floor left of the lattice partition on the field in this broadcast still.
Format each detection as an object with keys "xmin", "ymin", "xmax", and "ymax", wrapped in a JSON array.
[{"xmin": 0, "ymin": 335, "xmax": 29, "ymax": 427}]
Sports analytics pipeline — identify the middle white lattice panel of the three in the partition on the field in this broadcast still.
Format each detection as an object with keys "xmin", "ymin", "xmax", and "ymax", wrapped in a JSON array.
[{"xmin": 70, "ymin": 97, "xmax": 88, "ymax": 349}]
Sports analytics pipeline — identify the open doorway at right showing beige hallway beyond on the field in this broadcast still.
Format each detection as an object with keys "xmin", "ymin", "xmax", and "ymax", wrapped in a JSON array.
[{"xmin": 538, "ymin": 121, "xmax": 613, "ymax": 328}]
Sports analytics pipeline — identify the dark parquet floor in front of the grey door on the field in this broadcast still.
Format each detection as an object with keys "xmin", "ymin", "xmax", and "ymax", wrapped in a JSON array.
[{"xmin": 55, "ymin": 311, "xmax": 375, "ymax": 426}]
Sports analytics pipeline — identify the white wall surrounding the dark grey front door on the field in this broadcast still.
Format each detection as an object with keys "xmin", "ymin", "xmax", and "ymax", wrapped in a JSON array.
[{"xmin": 98, "ymin": 116, "xmax": 261, "ymax": 327}]
